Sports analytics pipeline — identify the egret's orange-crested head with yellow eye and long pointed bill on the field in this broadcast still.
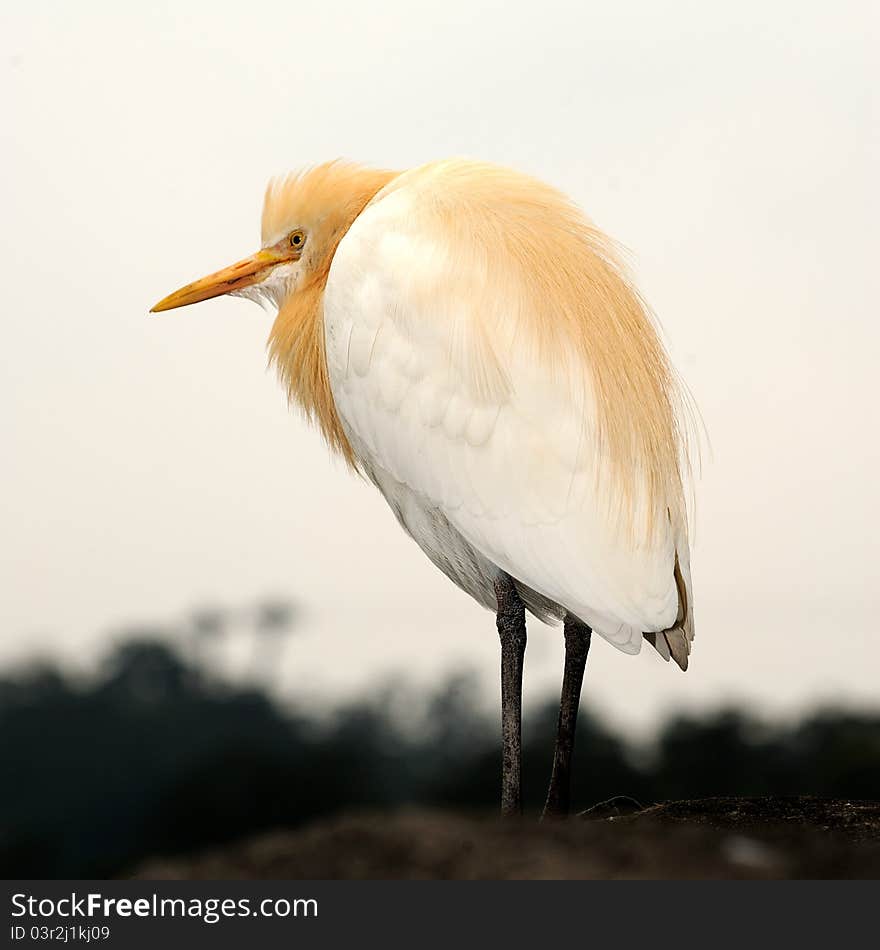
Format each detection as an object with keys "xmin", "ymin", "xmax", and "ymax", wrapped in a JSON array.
[{"xmin": 151, "ymin": 162, "xmax": 394, "ymax": 313}]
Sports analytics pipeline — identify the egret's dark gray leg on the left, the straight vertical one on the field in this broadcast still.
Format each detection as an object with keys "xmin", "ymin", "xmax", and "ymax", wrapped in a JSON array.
[{"xmin": 495, "ymin": 573, "xmax": 526, "ymax": 816}]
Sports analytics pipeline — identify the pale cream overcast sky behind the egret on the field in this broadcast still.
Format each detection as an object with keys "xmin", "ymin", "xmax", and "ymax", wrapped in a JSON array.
[{"xmin": 0, "ymin": 0, "xmax": 880, "ymax": 726}]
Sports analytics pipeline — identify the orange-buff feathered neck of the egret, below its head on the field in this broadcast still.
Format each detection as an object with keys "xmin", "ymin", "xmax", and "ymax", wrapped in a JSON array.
[{"xmin": 269, "ymin": 169, "xmax": 396, "ymax": 467}]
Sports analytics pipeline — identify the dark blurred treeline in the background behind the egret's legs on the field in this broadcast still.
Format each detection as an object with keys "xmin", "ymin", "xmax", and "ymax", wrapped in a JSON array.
[{"xmin": 0, "ymin": 617, "xmax": 880, "ymax": 878}]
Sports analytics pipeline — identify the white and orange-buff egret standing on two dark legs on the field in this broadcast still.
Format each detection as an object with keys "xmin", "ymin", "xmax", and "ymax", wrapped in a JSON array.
[{"xmin": 152, "ymin": 158, "xmax": 694, "ymax": 818}]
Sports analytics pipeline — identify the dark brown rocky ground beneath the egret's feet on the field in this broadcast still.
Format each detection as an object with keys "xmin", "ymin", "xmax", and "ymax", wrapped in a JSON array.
[{"xmin": 131, "ymin": 798, "xmax": 880, "ymax": 880}]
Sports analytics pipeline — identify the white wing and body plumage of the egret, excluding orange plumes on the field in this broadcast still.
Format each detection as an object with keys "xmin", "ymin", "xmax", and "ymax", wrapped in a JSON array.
[{"xmin": 324, "ymin": 164, "xmax": 690, "ymax": 656}]
